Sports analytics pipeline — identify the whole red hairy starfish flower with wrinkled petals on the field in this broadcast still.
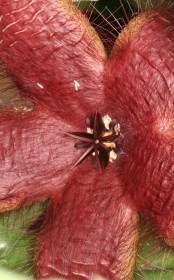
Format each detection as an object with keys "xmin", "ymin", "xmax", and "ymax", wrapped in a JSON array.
[{"xmin": 0, "ymin": 0, "xmax": 174, "ymax": 280}]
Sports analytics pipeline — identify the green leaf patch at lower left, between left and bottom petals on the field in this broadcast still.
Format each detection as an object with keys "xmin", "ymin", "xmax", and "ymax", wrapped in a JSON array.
[{"xmin": 0, "ymin": 203, "xmax": 46, "ymax": 275}]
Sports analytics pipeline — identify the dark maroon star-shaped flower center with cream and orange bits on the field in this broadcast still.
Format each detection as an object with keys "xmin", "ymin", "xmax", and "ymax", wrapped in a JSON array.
[{"xmin": 65, "ymin": 112, "xmax": 124, "ymax": 172}]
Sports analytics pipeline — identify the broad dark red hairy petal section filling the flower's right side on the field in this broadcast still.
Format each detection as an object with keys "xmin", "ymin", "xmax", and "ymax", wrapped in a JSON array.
[{"xmin": 105, "ymin": 11, "xmax": 174, "ymax": 245}]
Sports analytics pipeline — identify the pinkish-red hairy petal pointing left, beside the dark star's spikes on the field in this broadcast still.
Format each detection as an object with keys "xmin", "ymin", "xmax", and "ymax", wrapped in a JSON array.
[{"xmin": 0, "ymin": 109, "xmax": 78, "ymax": 212}]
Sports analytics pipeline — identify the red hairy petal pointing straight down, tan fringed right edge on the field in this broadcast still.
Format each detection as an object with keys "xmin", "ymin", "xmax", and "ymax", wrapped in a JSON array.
[{"xmin": 35, "ymin": 168, "xmax": 138, "ymax": 280}]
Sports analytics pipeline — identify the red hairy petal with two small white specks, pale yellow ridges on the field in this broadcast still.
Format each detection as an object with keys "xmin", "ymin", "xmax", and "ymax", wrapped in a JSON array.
[{"xmin": 0, "ymin": 0, "xmax": 106, "ymax": 125}]
